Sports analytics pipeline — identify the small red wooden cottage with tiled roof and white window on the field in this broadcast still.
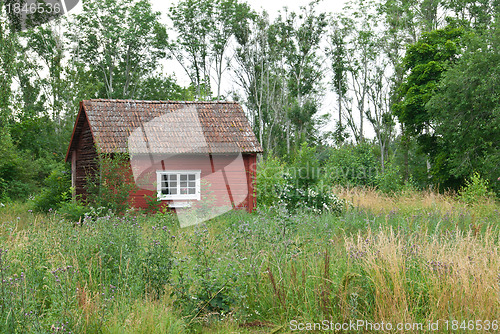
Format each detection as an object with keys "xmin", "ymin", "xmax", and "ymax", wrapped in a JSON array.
[{"xmin": 66, "ymin": 99, "xmax": 262, "ymax": 211}]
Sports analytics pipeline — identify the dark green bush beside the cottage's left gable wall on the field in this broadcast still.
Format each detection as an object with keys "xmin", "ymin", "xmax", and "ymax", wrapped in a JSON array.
[{"xmin": 33, "ymin": 165, "xmax": 71, "ymax": 212}]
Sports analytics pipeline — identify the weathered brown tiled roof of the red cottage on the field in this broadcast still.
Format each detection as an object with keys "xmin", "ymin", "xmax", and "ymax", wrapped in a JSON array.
[{"xmin": 72, "ymin": 99, "xmax": 262, "ymax": 154}]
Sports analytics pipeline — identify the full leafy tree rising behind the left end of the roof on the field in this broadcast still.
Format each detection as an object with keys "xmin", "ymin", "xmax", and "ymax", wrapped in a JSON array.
[{"xmin": 68, "ymin": 0, "xmax": 167, "ymax": 98}]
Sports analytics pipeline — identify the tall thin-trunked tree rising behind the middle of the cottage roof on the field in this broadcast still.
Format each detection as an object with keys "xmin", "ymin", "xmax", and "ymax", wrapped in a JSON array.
[{"xmin": 169, "ymin": 0, "xmax": 252, "ymax": 99}]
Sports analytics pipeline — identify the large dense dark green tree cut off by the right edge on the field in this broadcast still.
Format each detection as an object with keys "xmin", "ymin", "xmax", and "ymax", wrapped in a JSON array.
[{"xmin": 426, "ymin": 23, "xmax": 500, "ymax": 193}]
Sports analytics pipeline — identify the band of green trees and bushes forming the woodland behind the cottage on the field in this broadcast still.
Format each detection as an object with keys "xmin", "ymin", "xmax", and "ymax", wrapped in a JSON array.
[{"xmin": 0, "ymin": 0, "xmax": 500, "ymax": 206}]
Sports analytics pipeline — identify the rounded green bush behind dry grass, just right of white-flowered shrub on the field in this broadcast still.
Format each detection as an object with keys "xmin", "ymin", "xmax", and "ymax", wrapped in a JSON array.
[{"xmin": 322, "ymin": 142, "xmax": 379, "ymax": 187}]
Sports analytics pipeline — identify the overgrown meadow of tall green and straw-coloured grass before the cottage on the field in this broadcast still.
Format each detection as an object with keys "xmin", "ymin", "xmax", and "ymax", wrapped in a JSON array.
[{"xmin": 0, "ymin": 188, "xmax": 500, "ymax": 333}]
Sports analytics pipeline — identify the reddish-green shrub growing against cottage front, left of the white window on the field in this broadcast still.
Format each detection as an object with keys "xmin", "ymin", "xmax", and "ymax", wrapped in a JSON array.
[{"xmin": 86, "ymin": 153, "xmax": 137, "ymax": 213}]
